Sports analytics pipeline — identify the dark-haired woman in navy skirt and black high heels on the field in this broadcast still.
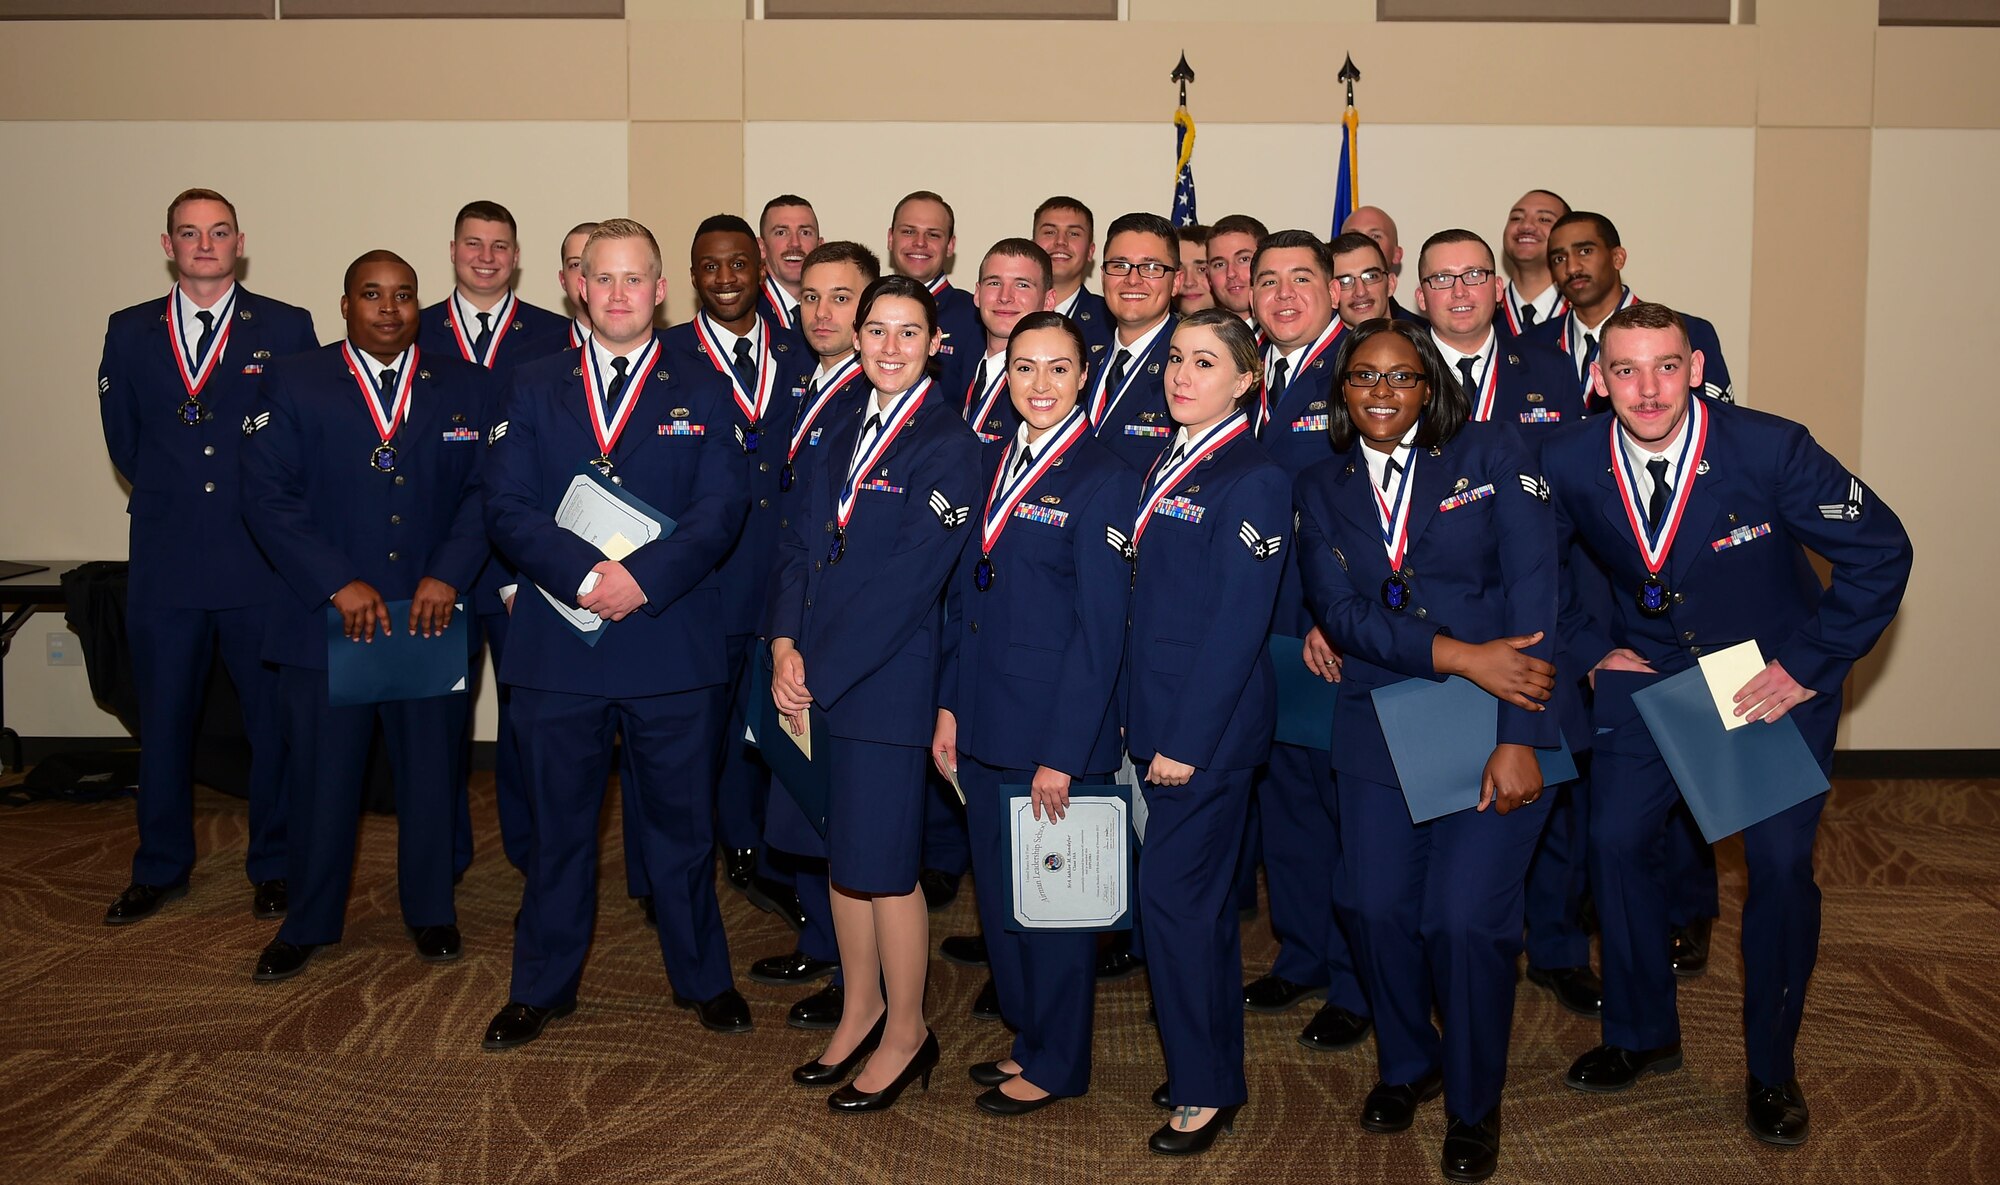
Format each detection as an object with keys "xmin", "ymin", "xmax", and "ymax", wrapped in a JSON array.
[{"xmin": 766, "ymin": 276, "xmax": 980, "ymax": 1111}]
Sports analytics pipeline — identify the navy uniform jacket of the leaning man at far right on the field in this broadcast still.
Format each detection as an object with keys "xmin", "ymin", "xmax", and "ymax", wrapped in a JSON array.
[{"xmin": 1542, "ymin": 396, "xmax": 1912, "ymax": 767}]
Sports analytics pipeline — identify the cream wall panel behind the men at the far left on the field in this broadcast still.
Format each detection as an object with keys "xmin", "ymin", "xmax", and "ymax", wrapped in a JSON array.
[{"xmin": 0, "ymin": 122, "xmax": 626, "ymax": 735}]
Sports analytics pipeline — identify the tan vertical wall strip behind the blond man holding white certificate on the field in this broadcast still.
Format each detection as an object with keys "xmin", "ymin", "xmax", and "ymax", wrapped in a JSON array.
[{"xmin": 630, "ymin": 122, "xmax": 748, "ymax": 322}]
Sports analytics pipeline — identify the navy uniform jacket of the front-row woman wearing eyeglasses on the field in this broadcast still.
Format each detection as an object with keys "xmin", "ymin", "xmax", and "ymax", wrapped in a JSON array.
[{"xmin": 1296, "ymin": 422, "xmax": 1564, "ymax": 787}]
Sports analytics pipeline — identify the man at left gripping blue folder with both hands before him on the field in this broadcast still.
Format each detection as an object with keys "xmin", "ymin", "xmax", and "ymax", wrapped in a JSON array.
[{"xmin": 242, "ymin": 250, "xmax": 492, "ymax": 981}]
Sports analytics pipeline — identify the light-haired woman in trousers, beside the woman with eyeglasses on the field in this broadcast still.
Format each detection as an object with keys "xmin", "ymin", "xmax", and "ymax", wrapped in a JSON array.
[{"xmin": 1108, "ymin": 308, "xmax": 1292, "ymax": 1155}]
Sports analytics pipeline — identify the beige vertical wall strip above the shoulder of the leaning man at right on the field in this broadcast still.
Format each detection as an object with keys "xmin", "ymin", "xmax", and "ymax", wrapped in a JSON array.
[{"xmin": 1752, "ymin": 128, "xmax": 1872, "ymax": 466}]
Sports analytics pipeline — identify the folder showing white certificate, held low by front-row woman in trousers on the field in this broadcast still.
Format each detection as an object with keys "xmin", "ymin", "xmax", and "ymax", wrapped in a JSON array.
[{"xmin": 996, "ymin": 781, "xmax": 1138, "ymax": 933}]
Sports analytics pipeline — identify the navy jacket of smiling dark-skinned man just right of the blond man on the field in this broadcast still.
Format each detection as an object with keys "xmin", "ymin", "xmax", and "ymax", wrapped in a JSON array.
[{"xmin": 660, "ymin": 318, "xmax": 824, "ymax": 637}]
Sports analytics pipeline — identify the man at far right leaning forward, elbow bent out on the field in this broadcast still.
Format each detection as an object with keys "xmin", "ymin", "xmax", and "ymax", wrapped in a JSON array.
[{"xmin": 1542, "ymin": 304, "xmax": 1910, "ymax": 1145}]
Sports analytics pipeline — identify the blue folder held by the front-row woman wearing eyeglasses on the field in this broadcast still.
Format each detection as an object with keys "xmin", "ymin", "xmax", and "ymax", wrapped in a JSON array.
[{"xmin": 1374, "ymin": 675, "xmax": 1576, "ymax": 823}]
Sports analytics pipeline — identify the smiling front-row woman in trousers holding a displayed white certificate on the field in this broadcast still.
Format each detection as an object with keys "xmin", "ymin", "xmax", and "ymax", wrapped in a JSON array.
[{"xmin": 930, "ymin": 312, "xmax": 1138, "ymax": 1115}]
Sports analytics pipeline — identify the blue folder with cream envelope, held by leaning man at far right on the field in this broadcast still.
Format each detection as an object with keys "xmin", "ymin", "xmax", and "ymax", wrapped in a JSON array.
[{"xmin": 1632, "ymin": 667, "xmax": 1828, "ymax": 843}]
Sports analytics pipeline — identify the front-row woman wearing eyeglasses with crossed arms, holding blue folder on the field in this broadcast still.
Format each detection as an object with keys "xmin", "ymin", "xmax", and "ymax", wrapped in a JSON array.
[{"xmin": 1294, "ymin": 318, "xmax": 1558, "ymax": 1181}]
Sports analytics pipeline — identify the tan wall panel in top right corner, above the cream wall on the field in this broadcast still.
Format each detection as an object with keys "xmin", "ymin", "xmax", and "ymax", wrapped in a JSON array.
[{"xmin": 1874, "ymin": 28, "xmax": 2000, "ymax": 128}]
